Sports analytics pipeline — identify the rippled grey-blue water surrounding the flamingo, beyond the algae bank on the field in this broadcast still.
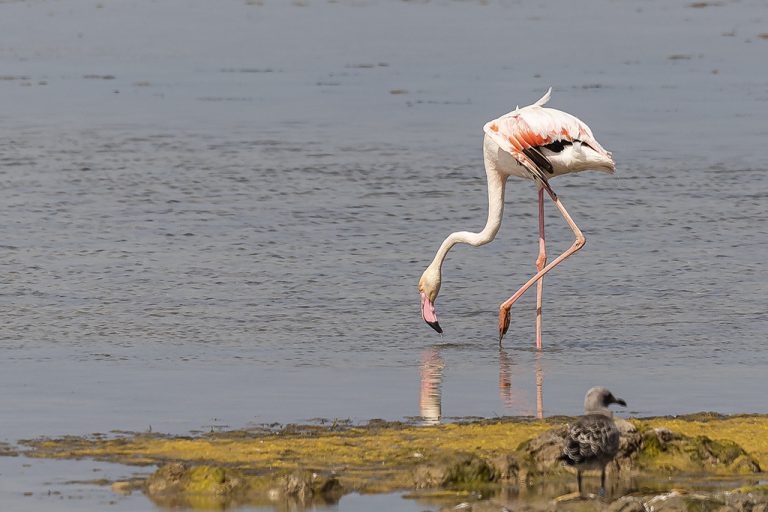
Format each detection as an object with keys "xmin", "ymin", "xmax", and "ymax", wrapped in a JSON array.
[{"xmin": 0, "ymin": 0, "xmax": 768, "ymax": 510}]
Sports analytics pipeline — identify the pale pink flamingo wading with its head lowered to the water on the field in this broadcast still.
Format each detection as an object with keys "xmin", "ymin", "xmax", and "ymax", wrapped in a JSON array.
[{"xmin": 419, "ymin": 87, "xmax": 615, "ymax": 350}]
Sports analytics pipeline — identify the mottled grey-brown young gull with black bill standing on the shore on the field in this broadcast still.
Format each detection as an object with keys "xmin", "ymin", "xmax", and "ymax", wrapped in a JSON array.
[{"xmin": 560, "ymin": 387, "xmax": 627, "ymax": 496}]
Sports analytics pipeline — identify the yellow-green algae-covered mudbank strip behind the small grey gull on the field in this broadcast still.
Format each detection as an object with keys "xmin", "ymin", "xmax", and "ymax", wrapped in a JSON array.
[{"xmin": 16, "ymin": 414, "xmax": 768, "ymax": 507}]
